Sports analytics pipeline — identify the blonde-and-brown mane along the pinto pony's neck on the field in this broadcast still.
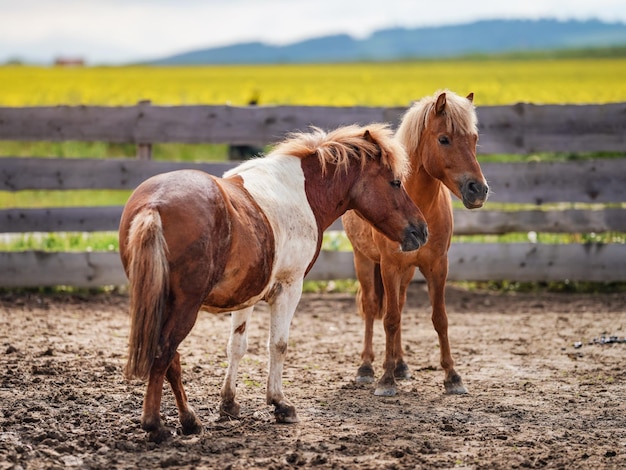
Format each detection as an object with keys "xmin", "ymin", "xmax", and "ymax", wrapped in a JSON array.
[{"xmin": 270, "ymin": 123, "xmax": 410, "ymax": 179}]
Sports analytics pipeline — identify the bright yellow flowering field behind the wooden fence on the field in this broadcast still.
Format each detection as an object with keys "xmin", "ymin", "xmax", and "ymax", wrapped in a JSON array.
[{"xmin": 0, "ymin": 58, "xmax": 626, "ymax": 106}]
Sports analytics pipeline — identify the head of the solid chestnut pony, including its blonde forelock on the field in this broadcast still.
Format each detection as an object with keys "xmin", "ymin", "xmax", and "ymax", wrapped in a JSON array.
[{"xmin": 396, "ymin": 90, "xmax": 489, "ymax": 209}]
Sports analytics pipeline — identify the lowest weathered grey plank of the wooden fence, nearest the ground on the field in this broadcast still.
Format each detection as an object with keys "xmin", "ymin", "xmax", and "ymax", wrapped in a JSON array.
[{"xmin": 0, "ymin": 243, "xmax": 626, "ymax": 287}]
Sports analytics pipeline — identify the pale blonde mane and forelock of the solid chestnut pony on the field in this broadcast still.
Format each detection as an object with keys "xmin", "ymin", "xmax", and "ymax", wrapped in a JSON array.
[{"xmin": 396, "ymin": 90, "xmax": 478, "ymax": 153}]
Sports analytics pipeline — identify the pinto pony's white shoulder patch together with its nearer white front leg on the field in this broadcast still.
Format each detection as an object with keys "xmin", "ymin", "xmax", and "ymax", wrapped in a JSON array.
[{"xmin": 224, "ymin": 154, "xmax": 318, "ymax": 414}]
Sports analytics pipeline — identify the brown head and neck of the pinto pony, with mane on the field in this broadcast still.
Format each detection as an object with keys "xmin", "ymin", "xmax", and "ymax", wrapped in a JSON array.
[{"xmin": 272, "ymin": 123, "xmax": 428, "ymax": 251}]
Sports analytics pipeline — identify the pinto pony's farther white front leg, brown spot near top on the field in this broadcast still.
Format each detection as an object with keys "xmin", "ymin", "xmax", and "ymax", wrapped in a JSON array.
[{"xmin": 220, "ymin": 307, "xmax": 254, "ymax": 418}]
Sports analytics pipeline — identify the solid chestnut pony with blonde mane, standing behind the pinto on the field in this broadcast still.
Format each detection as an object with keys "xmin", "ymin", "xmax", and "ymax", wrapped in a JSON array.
[{"xmin": 342, "ymin": 91, "xmax": 489, "ymax": 396}]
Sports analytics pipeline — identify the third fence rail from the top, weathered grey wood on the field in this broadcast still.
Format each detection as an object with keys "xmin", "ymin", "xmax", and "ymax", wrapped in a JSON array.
[{"xmin": 0, "ymin": 206, "xmax": 626, "ymax": 235}]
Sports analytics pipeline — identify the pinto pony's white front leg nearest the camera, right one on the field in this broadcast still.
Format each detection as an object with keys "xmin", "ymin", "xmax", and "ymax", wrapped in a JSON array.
[{"xmin": 267, "ymin": 279, "xmax": 302, "ymax": 423}]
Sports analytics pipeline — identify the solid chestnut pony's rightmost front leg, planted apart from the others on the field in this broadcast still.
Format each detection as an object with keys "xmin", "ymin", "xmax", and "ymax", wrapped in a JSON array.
[{"xmin": 424, "ymin": 257, "xmax": 467, "ymax": 394}]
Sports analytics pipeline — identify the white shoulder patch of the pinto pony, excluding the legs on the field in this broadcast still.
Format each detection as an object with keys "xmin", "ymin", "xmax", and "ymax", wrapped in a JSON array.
[{"xmin": 224, "ymin": 154, "xmax": 318, "ymax": 285}]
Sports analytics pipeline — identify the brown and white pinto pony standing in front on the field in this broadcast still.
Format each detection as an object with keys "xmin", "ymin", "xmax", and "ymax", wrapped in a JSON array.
[{"xmin": 119, "ymin": 124, "xmax": 427, "ymax": 442}]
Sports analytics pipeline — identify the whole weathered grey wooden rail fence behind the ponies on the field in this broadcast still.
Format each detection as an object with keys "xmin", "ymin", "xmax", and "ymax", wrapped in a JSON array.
[{"xmin": 0, "ymin": 103, "xmax": 626, "ymax": 287}]
